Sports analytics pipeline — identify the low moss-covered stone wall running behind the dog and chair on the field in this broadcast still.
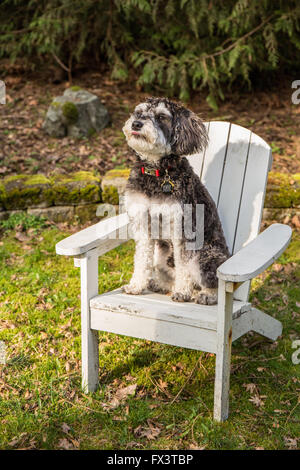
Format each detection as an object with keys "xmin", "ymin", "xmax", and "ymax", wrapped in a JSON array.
[{"xmin": 0, "ymin": 169, "xmax": 300, "ymax": 223}]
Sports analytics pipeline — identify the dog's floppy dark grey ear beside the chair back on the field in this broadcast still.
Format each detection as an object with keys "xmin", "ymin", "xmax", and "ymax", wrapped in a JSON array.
[{"xmin": 171, "ymin": 108, "xmax": 208, "ymax": 155}]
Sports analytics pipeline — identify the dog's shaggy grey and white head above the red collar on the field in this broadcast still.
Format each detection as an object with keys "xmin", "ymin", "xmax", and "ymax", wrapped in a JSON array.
[{"xmin": 123, "ymin": 98, "xmax": 208, "ymax": 161}]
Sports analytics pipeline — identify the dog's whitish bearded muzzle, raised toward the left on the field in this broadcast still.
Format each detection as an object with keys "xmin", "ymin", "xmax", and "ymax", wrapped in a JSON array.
[{"xmin": 123, "ymin": 117, "xmax": 171, "ymax": 162}]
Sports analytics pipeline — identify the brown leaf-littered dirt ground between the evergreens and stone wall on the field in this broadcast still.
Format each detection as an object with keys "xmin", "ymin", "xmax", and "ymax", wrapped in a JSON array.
[{"xmin": 0, "ymin": 68, "xmax": 300, "ymax": 176}]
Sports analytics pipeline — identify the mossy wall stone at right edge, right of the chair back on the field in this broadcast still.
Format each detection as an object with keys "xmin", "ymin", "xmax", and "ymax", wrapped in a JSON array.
[{"xmin": 265, "ymin": 172, "xmax": 300, "ymax": 208}]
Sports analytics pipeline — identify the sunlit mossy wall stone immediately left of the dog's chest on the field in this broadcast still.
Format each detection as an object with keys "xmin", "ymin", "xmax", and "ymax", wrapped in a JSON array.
[{"xmin": 102, "ymin": 168, "xmax": 130, "ymax": 204}]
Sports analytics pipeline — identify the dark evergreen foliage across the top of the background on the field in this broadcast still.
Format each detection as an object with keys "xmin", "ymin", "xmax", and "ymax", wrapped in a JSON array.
[{"xmin": 0, "ymin": 0, "xmax": 300, "ymax": 108}]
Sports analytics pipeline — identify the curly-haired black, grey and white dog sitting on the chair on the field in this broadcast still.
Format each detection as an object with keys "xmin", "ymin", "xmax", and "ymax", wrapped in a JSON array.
[{"xmin": 123, "ymin": 98, "xmax": 229, "ymax": 305}]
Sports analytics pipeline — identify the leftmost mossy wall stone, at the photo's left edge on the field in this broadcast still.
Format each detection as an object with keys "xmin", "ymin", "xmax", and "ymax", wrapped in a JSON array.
[{"xmin": 0, "ymin": 174, "xmax": 53, "ymax": 210}]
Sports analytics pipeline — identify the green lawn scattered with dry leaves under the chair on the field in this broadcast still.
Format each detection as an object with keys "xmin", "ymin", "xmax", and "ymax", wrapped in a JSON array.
[{"xmin": 0, "ymin": 222, "xmax": 300, "ymax": 449}]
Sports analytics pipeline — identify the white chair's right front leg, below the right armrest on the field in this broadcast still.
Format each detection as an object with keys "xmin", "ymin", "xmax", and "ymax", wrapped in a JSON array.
[{"xmin": 214, "ymin": 280, "xmax": 233, "ymax": 421}]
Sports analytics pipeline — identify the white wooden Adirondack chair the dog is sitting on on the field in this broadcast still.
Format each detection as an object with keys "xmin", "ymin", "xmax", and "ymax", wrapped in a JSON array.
[{"xmin": 56, "ymin": 122, "xmax": 291, "ymax": 421}]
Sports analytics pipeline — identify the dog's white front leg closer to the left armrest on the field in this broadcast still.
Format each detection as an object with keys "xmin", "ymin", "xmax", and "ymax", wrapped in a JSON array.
[{"xmin": 122, "ymin": 238, "xmax": 154, "ymax": 295}]
